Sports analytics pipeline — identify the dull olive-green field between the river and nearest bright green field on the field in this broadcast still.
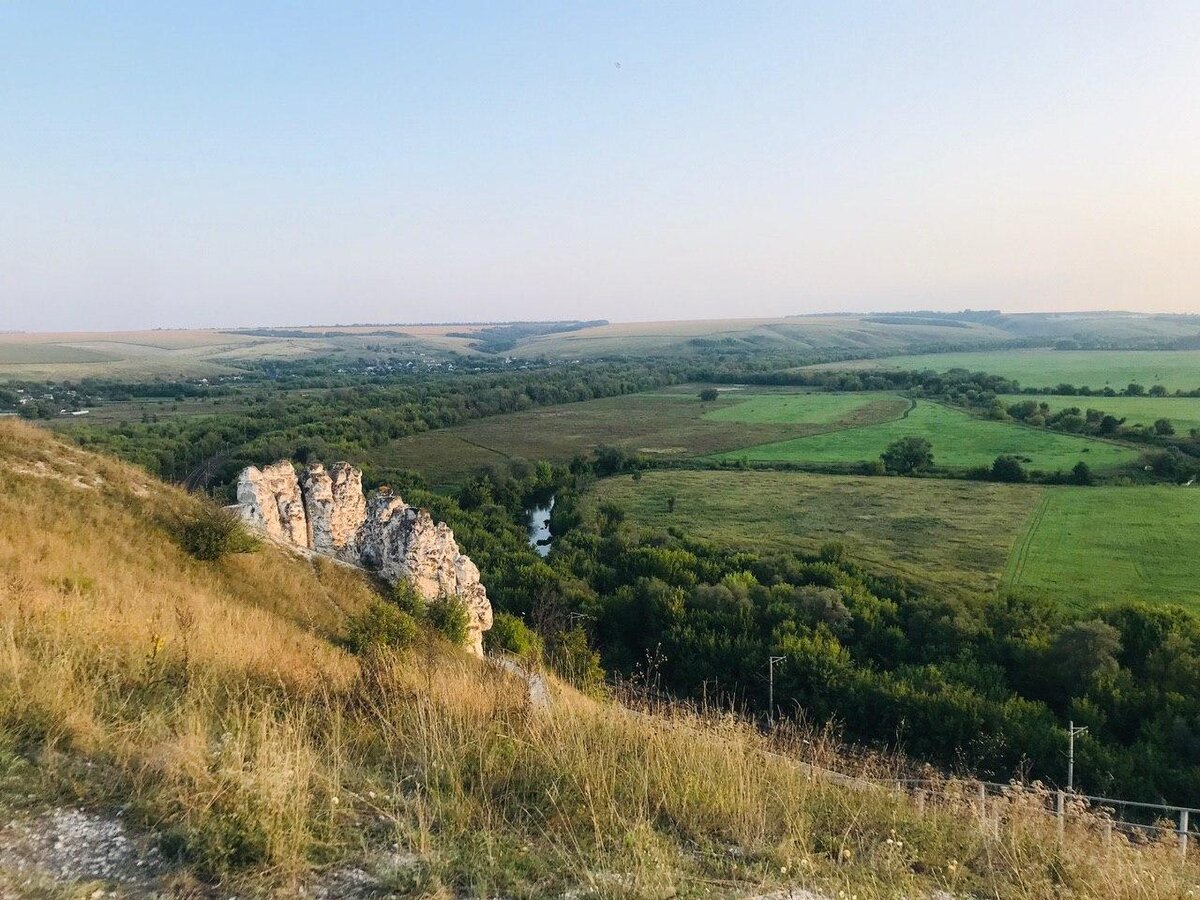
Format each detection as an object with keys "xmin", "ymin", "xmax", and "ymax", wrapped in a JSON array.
[{"xmin": 588, "ymin": 470, "xmax": 1051, "ymax": 595}]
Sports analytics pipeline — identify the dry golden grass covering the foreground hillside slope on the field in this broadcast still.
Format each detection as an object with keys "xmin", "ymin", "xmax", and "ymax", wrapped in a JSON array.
[{"xmin": 0, "ymin": 422, "xmax": 1198, "ymax": 900}]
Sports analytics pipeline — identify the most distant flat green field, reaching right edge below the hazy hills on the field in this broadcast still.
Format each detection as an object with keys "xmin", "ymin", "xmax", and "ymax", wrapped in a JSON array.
[{"xmin": 812, "ymin": 350, "xmax": 1200, "ymax": 391}]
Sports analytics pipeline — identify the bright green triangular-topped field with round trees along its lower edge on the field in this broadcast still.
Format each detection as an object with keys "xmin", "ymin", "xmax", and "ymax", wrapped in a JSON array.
[{"xmin": 715, "ymin": 401, "xmax": 1138, "ymax": 472}]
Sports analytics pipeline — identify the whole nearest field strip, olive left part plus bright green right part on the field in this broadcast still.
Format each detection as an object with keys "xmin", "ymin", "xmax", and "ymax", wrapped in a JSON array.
[{"xmin": 586, "ymin": 470, "xmax": 1200, "ymax": 612}]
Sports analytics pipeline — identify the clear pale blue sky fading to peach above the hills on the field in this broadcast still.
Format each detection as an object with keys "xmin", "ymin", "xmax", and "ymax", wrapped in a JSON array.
[{"xmin": 0, "ymin": 0, "xmax": 1200, "ymax": 331}]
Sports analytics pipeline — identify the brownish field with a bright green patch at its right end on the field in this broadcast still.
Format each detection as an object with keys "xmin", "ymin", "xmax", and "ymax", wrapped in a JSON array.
[{"xmin": 376, "ymin": 388, "xmax": 908, "ymax": 484}]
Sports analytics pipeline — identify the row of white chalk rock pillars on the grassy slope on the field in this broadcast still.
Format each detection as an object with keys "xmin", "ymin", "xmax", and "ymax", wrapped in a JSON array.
[{"xmin": 231, "ymin": 460, "xmax": 492, "ymax": 655}]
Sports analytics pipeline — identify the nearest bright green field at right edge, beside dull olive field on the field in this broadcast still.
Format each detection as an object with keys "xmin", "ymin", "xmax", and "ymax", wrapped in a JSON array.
[{"xmin": 1006, "ymin": 486, "xmax": 1200, "ymax": 611}]
